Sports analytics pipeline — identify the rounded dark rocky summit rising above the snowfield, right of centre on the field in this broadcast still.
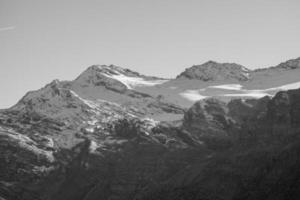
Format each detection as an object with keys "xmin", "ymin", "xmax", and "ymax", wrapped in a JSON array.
[{"xmin": 177, "ymin": 61, "xmax": 250, "ymax": 81}]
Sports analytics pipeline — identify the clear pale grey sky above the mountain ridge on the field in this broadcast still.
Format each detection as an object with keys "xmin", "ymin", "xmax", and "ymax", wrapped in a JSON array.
[{"xmin": 0, "ymin": 0, "xmax": 300, "ymax": 108}]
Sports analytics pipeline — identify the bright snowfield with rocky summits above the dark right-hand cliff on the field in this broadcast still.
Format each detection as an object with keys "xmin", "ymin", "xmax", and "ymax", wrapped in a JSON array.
[{"xmin": 137, "ymin": 58, "xmax": 300, "ymax": 107}]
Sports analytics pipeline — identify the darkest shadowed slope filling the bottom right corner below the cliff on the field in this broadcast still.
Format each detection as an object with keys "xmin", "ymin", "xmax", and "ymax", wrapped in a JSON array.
[{"xmin": 142, "ymin": 138, "xmax": 300, "ymax": 200}]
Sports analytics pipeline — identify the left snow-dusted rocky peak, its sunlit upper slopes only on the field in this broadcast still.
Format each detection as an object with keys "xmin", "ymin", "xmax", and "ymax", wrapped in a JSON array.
[{"xmin": 13, "ymin": 65, "xmax": 183, "ymax": 123}]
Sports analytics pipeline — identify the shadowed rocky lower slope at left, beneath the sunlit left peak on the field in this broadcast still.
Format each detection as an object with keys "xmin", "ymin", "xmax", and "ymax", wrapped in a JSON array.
[{"xmin": 0, "ymin": 111, "xmax": 202, "ymax": 200}]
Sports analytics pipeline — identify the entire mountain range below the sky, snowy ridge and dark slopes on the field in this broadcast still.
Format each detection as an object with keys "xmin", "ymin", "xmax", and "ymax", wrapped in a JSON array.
[{"xmin": 0, "ymin": 58, "xmax": 300, "ymax": 200}]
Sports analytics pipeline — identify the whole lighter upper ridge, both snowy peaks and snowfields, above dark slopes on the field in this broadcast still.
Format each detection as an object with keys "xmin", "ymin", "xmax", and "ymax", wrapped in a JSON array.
[{"xmin": 7, "ymin": 55, "xmax": 300, "ymax": 123}]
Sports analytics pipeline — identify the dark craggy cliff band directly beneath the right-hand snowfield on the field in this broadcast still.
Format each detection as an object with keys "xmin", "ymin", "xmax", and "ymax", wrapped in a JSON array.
[{"xmin": 183, "ymin": 89, "xmax": 300, "ymax": 138}]
